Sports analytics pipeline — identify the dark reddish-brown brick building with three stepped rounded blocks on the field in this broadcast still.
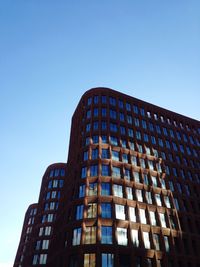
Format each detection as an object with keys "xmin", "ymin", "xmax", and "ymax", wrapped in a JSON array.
[{"xmin": 14, "ymin": 88, "xmax": 200, "ymax": 267}]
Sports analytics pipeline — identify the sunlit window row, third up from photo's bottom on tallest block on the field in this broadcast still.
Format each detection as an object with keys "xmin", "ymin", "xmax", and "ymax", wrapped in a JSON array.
[{"xmin": 75, "ymin": 203, "xmax": 176, "ymax": 229}]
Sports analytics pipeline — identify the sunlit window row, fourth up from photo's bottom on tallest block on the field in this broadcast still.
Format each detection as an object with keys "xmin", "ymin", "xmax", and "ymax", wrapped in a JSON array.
[{"xmin": 78, "ymin": 182, "xmax": 173, "ymax": 208}]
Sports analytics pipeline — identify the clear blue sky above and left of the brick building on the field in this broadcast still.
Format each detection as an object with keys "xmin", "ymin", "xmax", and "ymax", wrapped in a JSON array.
[{"xmin": 0, "ymin": 0, "xmax": 200, "ymax": 267}]
